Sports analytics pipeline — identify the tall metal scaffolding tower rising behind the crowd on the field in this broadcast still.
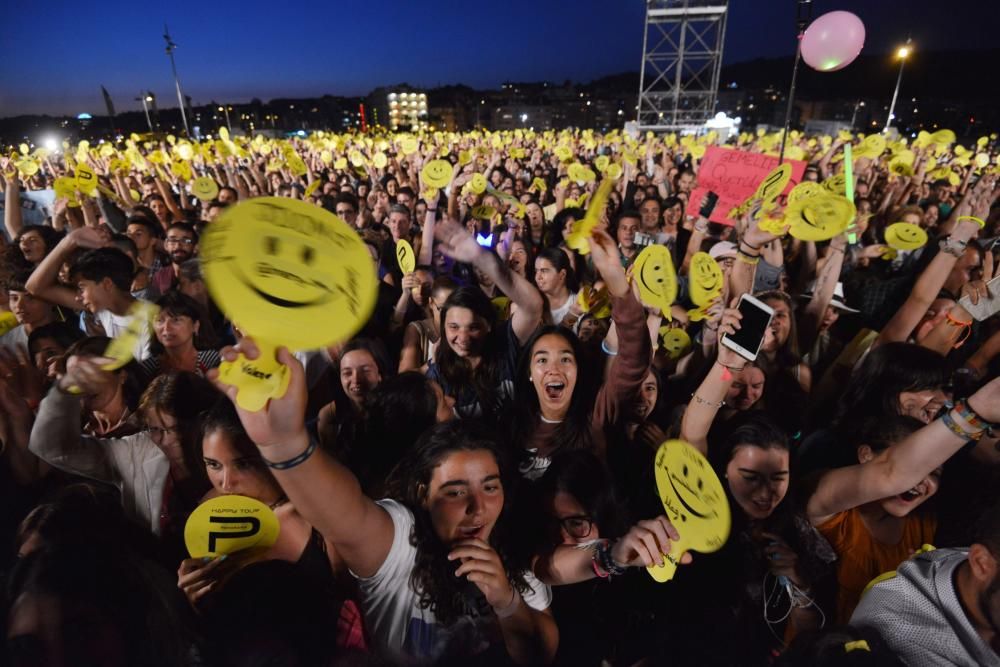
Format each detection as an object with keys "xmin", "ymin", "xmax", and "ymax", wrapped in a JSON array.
[{"xmin": 636, "ymin": 0, "xmax": 728, "ymax": 131}]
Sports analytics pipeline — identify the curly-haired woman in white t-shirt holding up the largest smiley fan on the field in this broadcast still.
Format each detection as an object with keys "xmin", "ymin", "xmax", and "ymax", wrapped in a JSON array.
[{"xmin": 213, "ymin": 339, "xmax": 557, "ymax": 664}]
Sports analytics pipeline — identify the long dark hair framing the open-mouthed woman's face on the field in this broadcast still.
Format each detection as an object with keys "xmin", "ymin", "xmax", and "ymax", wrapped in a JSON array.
[{"xmin": 510, "ymin": 325, "xmax": 595, "ymax": 462}]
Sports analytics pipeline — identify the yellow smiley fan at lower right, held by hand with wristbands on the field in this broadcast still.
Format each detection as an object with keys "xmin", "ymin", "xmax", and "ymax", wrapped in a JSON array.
[{"xmin": 647, "ymin": 440, "xmax": 732, "ymax": 583}]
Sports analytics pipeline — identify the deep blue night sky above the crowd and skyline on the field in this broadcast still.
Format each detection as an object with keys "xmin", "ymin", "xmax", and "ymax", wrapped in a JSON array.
[{"xmin": 0, "ymin": 0, "xmax": 1000, "ymax": 117}]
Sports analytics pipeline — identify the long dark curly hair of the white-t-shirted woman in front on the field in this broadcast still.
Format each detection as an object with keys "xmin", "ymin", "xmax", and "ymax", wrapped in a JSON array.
[{"xmin": 387, "ymin": 420, "xmax": 528, "ymax": 625}]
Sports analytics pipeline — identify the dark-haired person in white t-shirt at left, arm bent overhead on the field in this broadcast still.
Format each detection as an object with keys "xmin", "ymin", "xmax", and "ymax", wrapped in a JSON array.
[{"xmin": 26, "ymin": 227, "xmax": 152, "ymax": 361}]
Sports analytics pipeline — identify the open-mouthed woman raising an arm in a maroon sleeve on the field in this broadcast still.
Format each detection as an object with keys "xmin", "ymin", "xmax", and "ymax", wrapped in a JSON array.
[{"xmin": 511, "ymin": 231, "xmax": 650, "ymax": 479}]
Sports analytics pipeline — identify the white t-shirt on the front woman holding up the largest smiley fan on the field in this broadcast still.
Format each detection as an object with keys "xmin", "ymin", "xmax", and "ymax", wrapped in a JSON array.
[{"xmin": 358, "ymin": 500, "xmax": 552, "ymax": 664}]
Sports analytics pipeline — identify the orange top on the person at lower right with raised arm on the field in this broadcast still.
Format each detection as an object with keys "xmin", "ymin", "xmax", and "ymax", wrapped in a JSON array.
[{"xmin": 816, "ymin": 507, "xmax": 937, "ymax": 625}]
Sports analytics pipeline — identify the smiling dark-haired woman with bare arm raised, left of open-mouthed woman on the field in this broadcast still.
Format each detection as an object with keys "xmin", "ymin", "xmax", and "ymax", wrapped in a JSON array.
[{"xmin": 427, "ymin": 221, "xmax": 543, "ymax": 420}]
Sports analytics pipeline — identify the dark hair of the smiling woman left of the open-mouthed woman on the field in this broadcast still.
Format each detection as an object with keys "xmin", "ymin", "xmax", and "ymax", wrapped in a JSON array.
[{"xmin": 434, "ymin": 287, "xmax": 501, "ymax": 417}]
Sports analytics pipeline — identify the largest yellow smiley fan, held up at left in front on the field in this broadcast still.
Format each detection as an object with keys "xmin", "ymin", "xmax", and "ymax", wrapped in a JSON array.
[{"xmin": 201, "ymin": 197, "xmax": 378, "ymax": 410}]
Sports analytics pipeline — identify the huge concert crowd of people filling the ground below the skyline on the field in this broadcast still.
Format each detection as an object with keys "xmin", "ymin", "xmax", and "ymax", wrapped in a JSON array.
[{"xmin": 0, "ymin": 124, "xmax": 1000, "ymax": 667}]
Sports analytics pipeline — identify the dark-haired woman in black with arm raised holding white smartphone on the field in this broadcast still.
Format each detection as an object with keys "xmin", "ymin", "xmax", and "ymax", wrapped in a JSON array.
[{"xmin": 680, "ymin": 318, "xmax": 834, "ymax": 664}]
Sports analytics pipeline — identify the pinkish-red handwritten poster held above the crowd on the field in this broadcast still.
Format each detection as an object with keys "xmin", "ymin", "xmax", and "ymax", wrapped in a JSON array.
[{"xmin": 687, "ymin": 146, "xmax": 806, "ymax": 225}]
